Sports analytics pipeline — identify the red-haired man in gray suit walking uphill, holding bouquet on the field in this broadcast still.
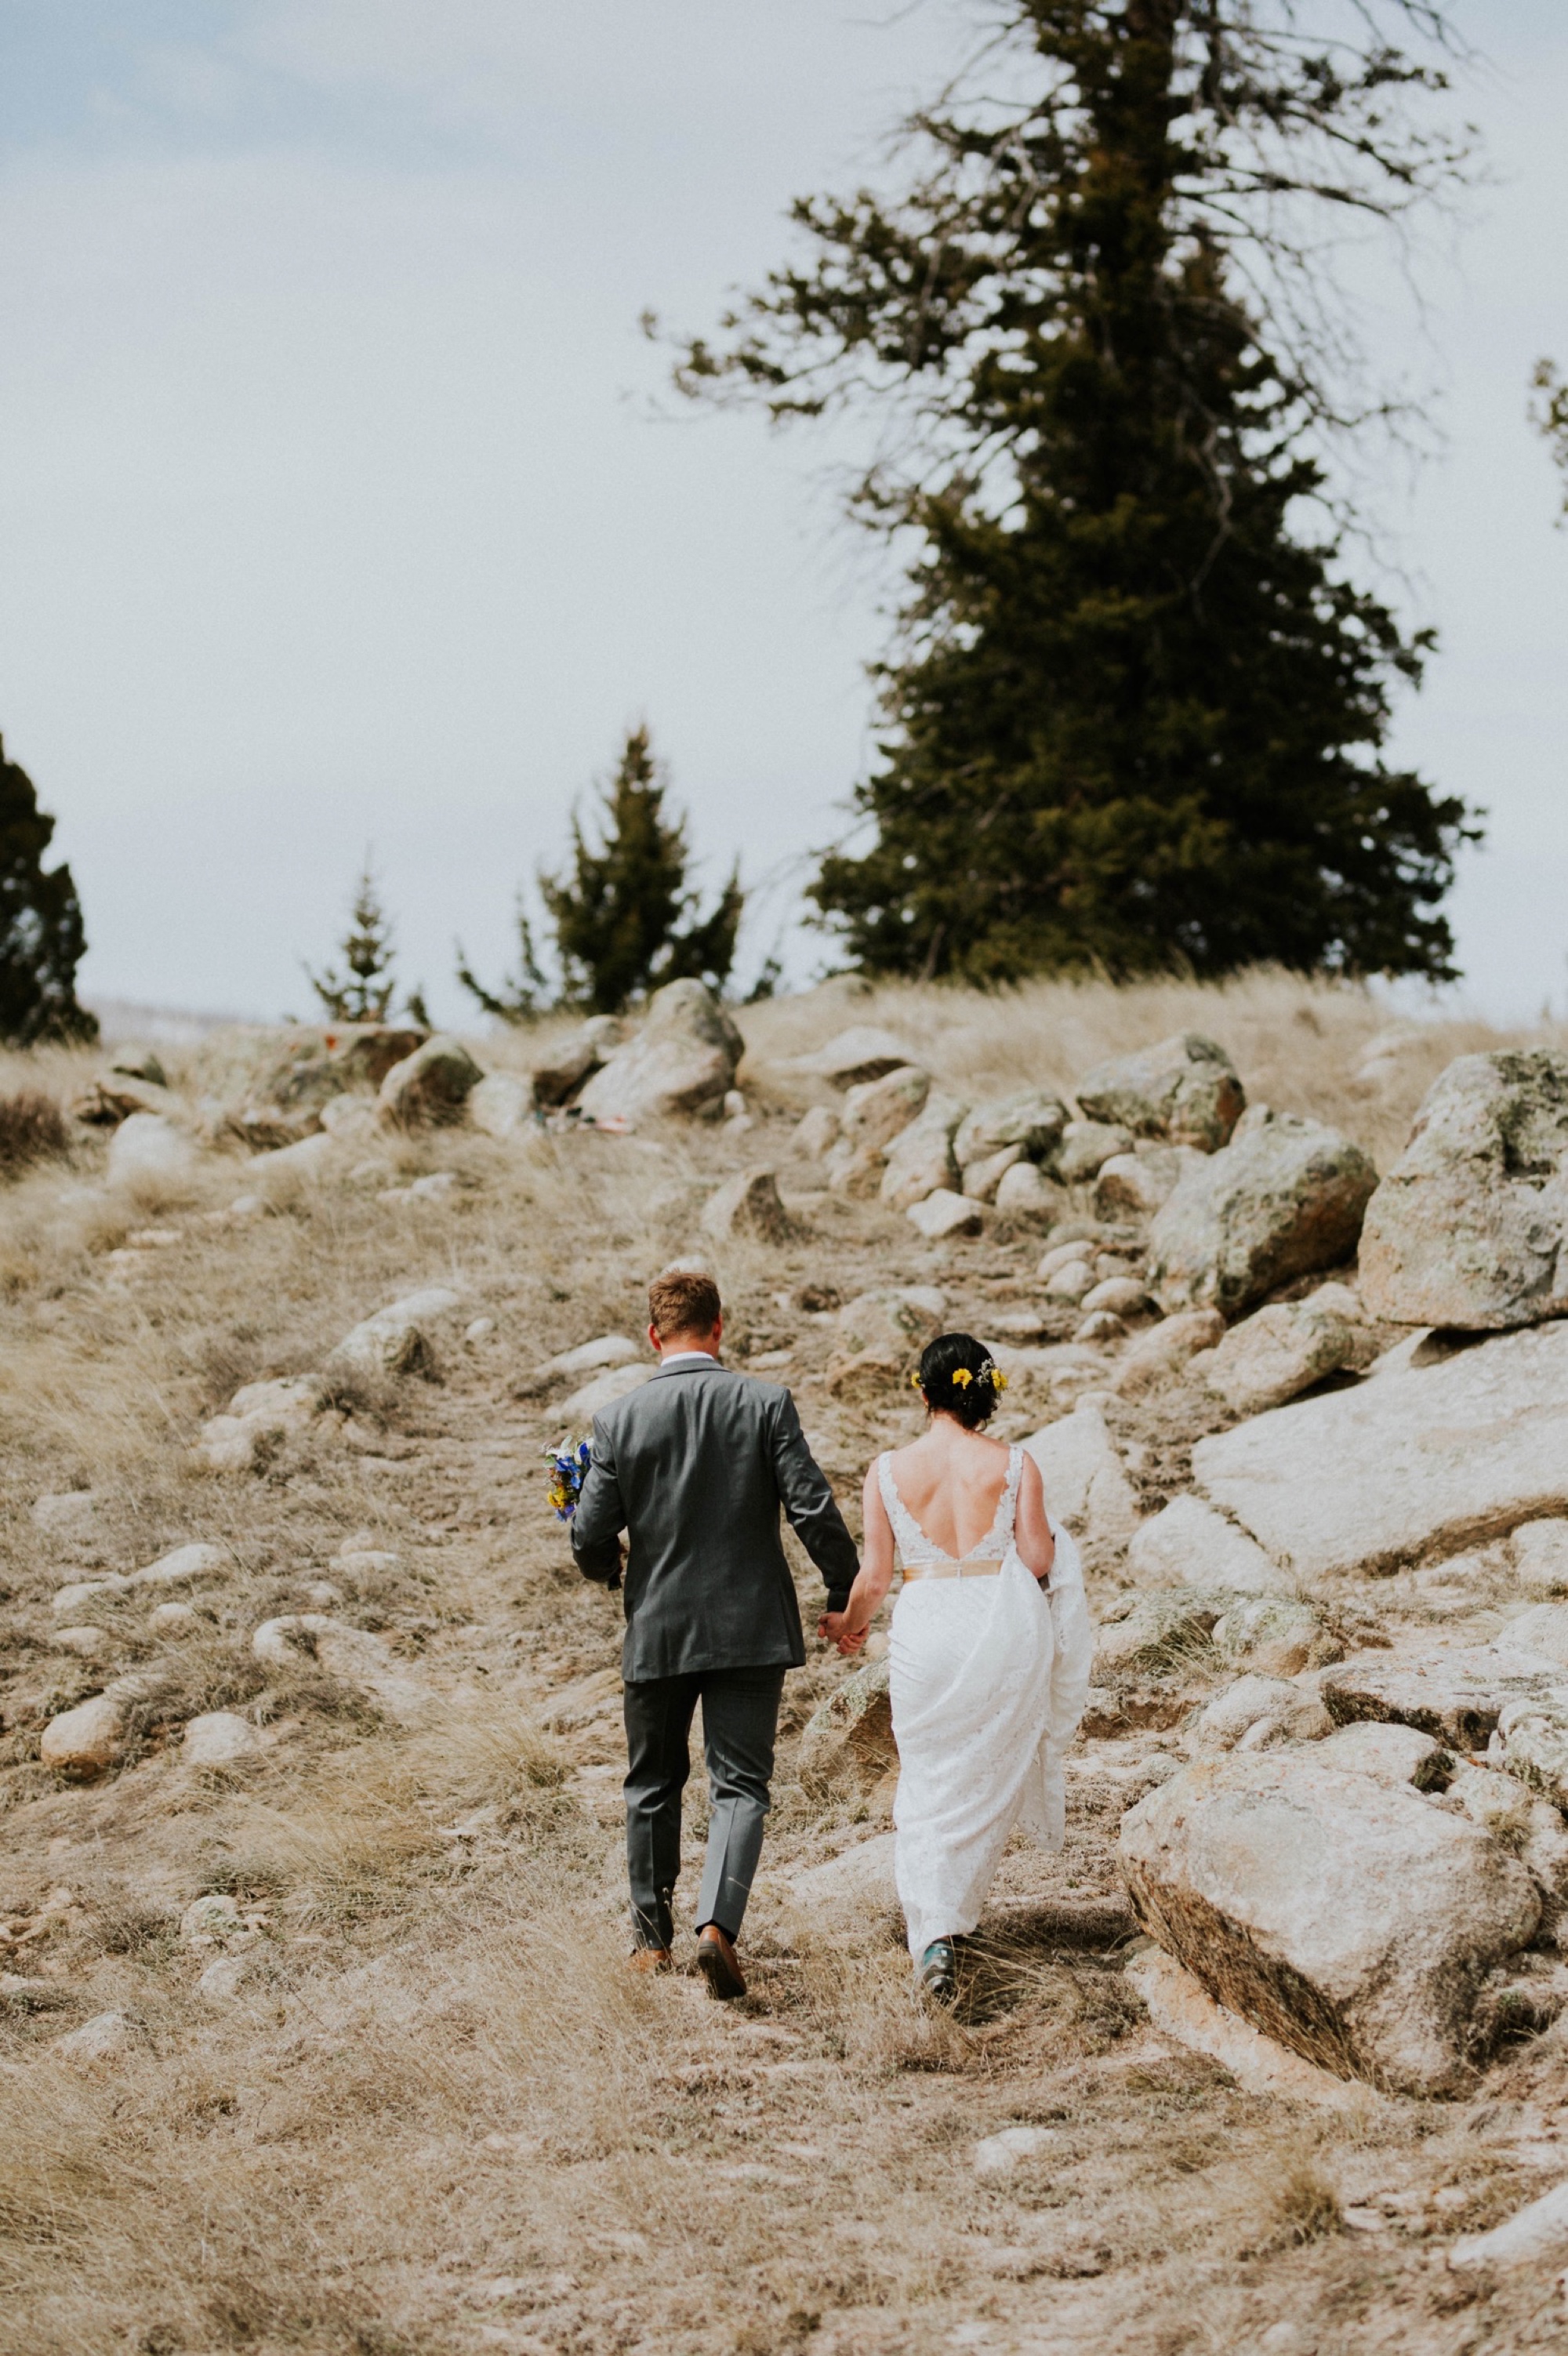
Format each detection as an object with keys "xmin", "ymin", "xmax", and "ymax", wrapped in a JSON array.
[{"xmin": 572, "ymin": 1270, "xmax": 857, "ymax": 1998}]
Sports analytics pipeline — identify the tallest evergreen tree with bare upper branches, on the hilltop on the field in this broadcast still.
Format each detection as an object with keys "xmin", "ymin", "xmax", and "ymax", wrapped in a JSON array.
[{"xmin": 678, "ymin": 0, "xmax": 1476, "ymax": 980}]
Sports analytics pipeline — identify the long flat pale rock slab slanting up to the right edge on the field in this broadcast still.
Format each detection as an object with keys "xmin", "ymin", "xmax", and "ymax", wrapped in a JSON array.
[{"xmin": 1192, "ymin": 1324, "xmax": 1568, "ymax": 1581}]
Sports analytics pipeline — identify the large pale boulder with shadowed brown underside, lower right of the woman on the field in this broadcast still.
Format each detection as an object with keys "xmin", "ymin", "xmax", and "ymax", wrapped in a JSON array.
[{"xmin": 1120, "ymin": 1748, "xmax": 1540, "ymax": 2094}]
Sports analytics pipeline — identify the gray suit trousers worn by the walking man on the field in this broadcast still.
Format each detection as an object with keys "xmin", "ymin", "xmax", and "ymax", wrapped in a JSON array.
[{"xmin": 626, "ymin": 1666, "xmax": 784, "ymax": 1946}]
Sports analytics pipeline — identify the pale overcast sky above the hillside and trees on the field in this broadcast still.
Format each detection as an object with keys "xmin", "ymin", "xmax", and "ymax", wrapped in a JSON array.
[{"xmin": 0, "ymin": 0, "xmax": 1568, "ymax": 1018}]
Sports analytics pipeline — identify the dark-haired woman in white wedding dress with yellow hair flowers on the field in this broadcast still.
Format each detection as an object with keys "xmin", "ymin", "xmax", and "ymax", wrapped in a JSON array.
[{"xmin": 822, "ymin": 1334, "xmax": 1092, "ymax": 2002}]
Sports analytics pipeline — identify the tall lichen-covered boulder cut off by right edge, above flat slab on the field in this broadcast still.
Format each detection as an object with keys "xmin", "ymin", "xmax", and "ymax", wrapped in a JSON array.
[{"xmin": 1361, "ymin": 1046, "xmax": 1568, "ymax": 1331}]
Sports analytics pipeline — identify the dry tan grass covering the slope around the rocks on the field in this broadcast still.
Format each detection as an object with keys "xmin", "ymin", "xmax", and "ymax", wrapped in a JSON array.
[{"xmin": 0, "ymin": 975, "xmax": 1561, "ymax": 2356}]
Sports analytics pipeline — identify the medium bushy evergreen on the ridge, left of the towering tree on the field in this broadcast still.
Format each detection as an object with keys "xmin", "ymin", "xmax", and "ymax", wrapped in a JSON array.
[{"xmin": 539, "ymin": 728, "xmax": 746, "ymax": 1015}]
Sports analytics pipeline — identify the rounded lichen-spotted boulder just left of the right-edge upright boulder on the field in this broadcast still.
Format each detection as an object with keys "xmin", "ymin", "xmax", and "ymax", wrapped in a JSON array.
[{"xmin": 1149, "ymin": 1105, "xmax": 1377, "ymax": 1317}]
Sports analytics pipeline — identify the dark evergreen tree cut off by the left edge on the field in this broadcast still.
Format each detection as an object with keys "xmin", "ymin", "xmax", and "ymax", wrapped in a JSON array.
[{"xmin": 0, "ymin": 740, "xmax": 99, "ymax": 1046}]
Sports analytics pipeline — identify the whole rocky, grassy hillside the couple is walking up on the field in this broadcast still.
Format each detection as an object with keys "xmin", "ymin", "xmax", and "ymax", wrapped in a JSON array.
[{"xmin": 0, "ymin": 978, "xmax": 1568, "ymax": 2356}]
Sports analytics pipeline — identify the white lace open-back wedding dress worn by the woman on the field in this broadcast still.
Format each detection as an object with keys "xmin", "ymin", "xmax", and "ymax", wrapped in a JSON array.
[{"xmin": 876, "ymin": 1447, "xmax": 1094, "ymax": 1962}]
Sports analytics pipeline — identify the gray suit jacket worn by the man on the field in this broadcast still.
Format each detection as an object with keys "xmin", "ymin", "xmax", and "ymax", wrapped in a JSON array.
[{"xmin": 572, "ymin": 1360, "xmax": 857, "ymax": 1685}]
